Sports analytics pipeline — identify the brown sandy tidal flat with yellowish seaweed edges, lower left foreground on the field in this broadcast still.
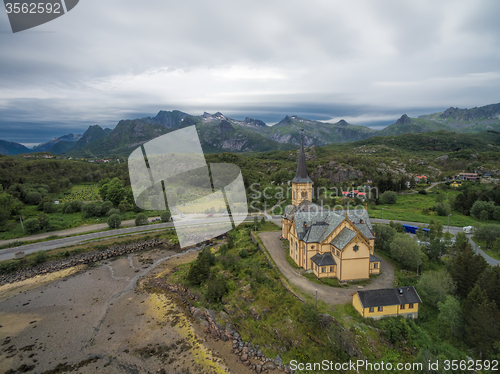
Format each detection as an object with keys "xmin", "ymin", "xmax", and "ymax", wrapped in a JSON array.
[{"xmin": 0, "ymin": 249, "xmax": 254, "ymax": 374}]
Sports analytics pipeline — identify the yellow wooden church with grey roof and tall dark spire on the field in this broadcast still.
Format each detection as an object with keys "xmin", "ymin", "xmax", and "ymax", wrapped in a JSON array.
[{"xmin": 282, "ymin": 137, "xmax": 380, "ymax": 281}]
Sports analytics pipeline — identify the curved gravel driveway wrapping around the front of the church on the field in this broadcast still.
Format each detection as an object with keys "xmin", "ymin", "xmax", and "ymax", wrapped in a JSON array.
[{"xmin": 259, "ymin": 231, "xmax": 394, "ymax": 305}]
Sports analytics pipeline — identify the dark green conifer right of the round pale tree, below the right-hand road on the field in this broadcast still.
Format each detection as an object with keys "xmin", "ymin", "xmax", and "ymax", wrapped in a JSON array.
[{"xmin": 450, "ymin": 246, "xmax": 488, "ymax": 299}]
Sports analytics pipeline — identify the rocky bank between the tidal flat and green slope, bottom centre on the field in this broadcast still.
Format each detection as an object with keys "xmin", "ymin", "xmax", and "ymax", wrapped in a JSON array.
[{"xmin": 148, "ymin": 278, "xmax": 294, "ymax": 374}]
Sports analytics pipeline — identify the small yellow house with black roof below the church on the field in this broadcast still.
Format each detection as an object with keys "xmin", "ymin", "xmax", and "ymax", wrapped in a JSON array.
[{"xmin": 352, "ymin": 286, "xmax": 422, "ymax": 319}]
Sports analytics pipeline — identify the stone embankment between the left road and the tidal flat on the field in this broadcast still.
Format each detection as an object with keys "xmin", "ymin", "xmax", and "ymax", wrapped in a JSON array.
[{"xmin": 0, "ymin": 238, "xmax": 167, "ymax": 286}]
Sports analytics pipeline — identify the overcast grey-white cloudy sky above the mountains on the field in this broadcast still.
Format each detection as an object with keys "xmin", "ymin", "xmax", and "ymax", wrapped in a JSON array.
[{"xmin": 0, "ymin": 0, "xmax": 500, "ymax": 145}]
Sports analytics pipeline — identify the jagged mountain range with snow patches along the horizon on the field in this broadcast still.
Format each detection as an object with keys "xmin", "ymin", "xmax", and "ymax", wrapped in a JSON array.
[{"xmin": 0, "ymin": 104, "xmax": 500, "ymax": 157}]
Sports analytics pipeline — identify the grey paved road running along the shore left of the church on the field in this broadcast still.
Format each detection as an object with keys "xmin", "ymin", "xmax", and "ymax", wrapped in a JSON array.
[{"xmin": 0, "ymin": 216, "xmax": 253, "ymax": 261}]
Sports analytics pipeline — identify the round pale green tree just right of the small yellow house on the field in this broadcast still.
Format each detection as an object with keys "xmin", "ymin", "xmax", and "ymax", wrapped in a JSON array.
[{"xmin": 417, "ymin": 269, "xmax": 455, "ymax": 307}]
